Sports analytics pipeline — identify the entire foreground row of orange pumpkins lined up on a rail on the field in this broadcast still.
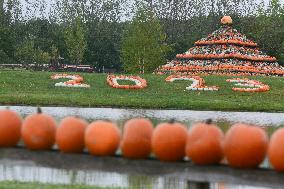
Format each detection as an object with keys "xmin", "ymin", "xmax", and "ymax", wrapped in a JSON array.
[{"xmin": 0, "ymin": 108, "xmax": 284, "ymax": 172}]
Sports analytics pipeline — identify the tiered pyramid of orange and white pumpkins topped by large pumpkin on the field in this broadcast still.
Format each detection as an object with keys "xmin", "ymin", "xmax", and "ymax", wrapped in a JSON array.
[{"xmin": 157, "ymin": 16, "xmax": 284, "ymax": 76}]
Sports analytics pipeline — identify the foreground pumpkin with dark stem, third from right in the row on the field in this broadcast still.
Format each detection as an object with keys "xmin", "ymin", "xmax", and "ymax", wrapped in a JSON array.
[{"xmin": 186, "ymin": 120, "xmax": 224, "ymax": 165}]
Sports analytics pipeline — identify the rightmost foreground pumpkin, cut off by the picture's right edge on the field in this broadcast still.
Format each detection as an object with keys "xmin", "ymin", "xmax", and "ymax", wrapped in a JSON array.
[{"xmin": 268, "ymin": 128, "xmax": 284, "ymax": 172}]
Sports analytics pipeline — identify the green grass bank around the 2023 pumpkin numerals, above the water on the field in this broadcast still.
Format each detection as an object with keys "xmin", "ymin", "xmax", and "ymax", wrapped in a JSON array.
[{"xmin": 0, "ymin": 71, "xmax": 284, "ymax": 112}]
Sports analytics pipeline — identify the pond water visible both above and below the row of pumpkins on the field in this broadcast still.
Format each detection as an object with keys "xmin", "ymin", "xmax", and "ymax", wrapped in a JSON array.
[{"xmin": 0, "ymin": 106, "xmax": 284, "ymax": 189}]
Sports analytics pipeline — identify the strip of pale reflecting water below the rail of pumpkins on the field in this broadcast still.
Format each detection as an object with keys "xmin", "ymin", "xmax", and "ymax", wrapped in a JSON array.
[{"xmin": 0, "ymin": 159, "xmax": 272, "ymax": 189}]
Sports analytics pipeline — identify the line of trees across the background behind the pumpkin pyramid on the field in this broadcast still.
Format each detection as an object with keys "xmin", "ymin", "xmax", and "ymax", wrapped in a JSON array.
[{"xmin": 0, "ymin": 0, "xmax": 284, "ymax": 72}]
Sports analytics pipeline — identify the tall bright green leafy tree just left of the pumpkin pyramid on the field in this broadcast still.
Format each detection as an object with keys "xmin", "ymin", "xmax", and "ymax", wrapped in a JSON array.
[{"xmin": 121, "ymin": 3, "xmax": 171, "ymax": 73}]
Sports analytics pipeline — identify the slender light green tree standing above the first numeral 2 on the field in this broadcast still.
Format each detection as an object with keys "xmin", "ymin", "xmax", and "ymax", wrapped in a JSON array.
[{"xmin": 64, "ymin": 17, "xmax": 87, "ymax": 64}]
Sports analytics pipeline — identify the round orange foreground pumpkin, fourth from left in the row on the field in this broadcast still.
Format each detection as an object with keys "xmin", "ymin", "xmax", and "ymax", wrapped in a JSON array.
[{"xmin": 85, "ymin": 121, "xmax": 120, "ymax": 156}]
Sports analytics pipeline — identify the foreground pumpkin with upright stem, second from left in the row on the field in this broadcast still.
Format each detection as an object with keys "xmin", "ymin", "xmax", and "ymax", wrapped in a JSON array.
[{"xmin": 21, "ymin": 108, "xmax": 56, "ymax": 150}]
